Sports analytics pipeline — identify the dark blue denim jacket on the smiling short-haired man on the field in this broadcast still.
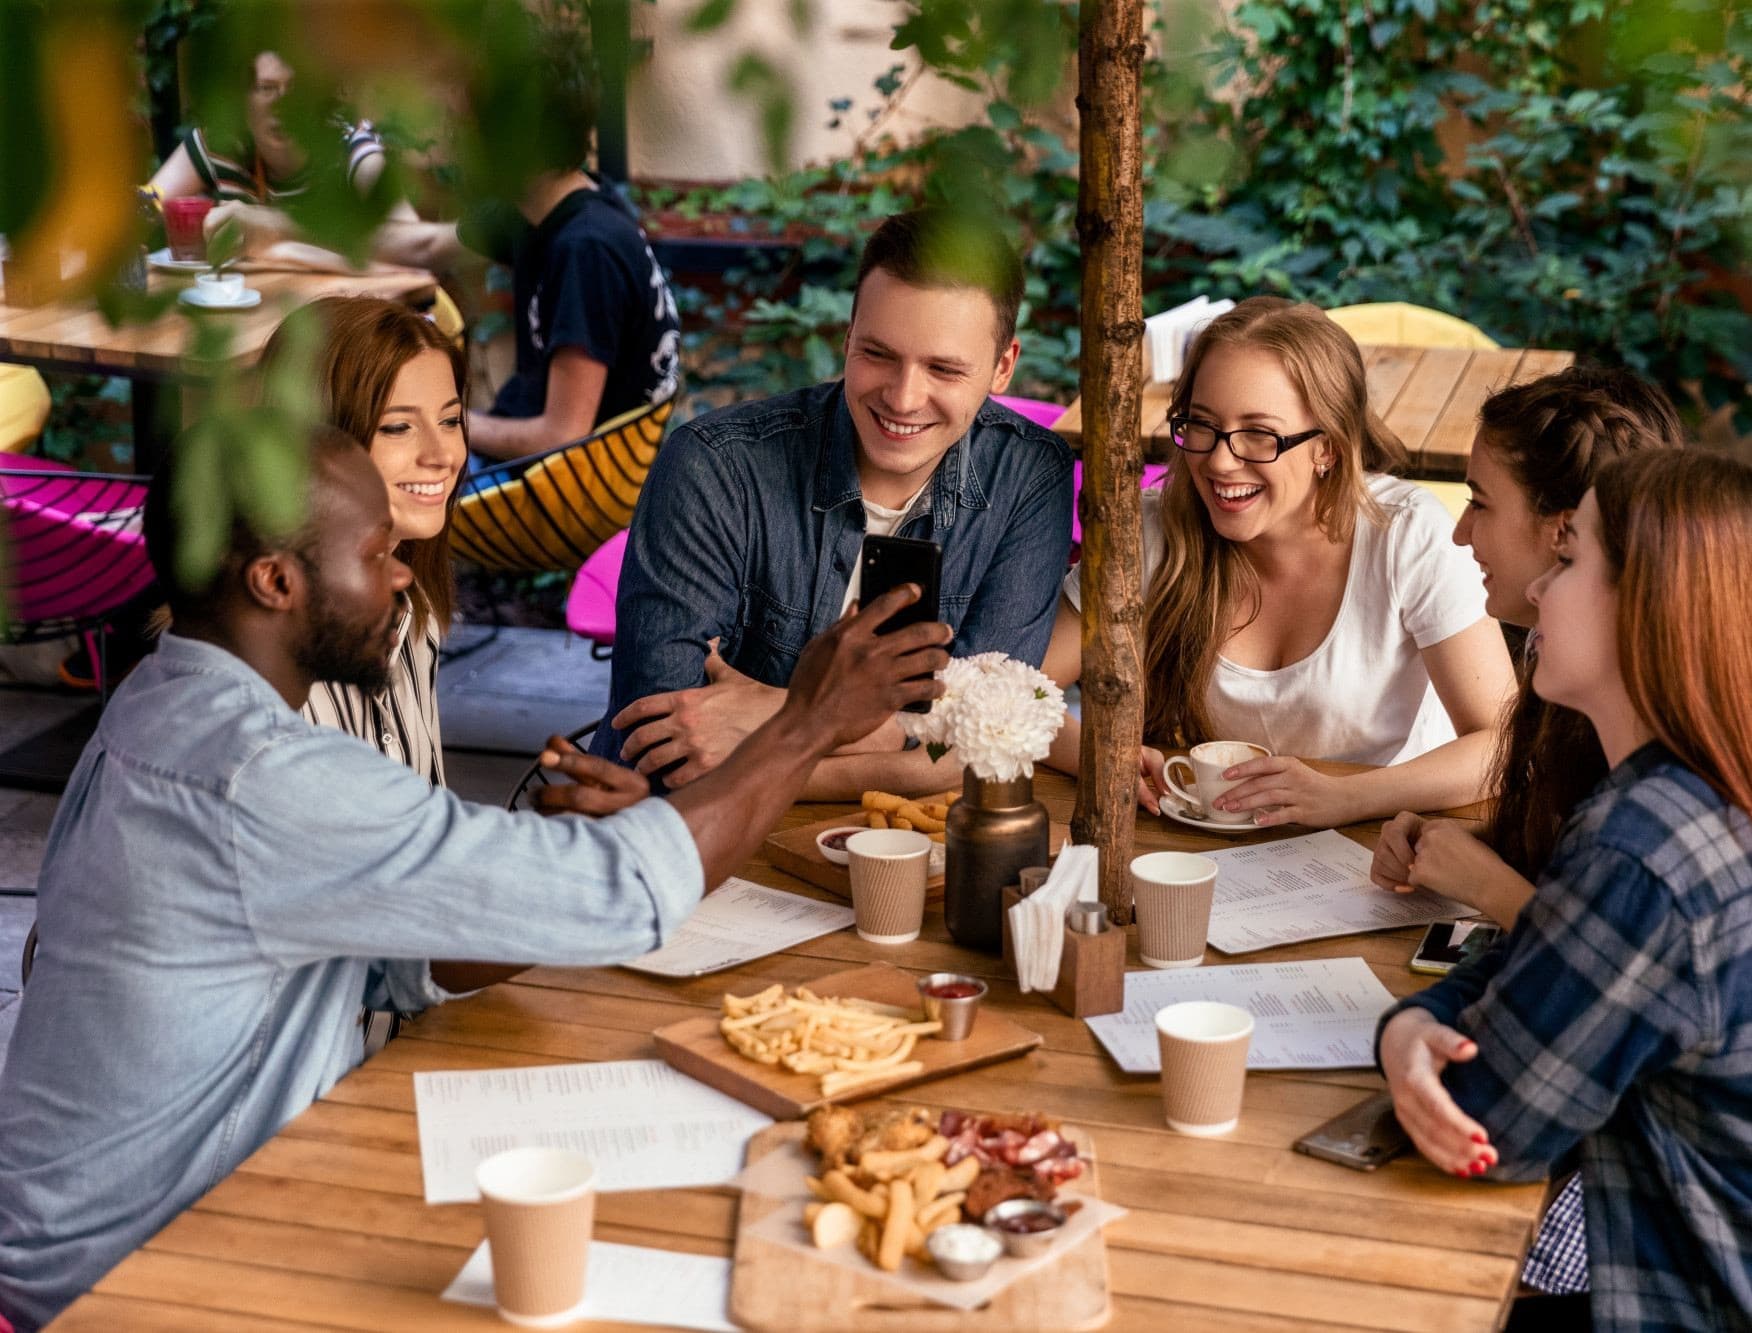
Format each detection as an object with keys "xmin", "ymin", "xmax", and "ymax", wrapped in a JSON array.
[{"xmin": 590, "ymin": 382, "xmax": 1070, "ymax": 758}]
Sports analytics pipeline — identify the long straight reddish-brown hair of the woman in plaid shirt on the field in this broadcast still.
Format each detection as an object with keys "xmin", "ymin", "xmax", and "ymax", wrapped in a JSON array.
[{"xmin": 1594, "ymin": 450, "xmax": 1752, "ymax": 815}]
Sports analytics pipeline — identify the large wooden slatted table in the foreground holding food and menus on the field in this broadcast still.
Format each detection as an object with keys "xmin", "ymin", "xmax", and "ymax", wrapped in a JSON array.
[{"xmin": 56, "ymin": 774, "xmax": 1544, "ymax": 1333}]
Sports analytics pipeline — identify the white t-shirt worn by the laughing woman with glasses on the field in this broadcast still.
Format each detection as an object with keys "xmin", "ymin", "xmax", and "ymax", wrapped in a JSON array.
[{"xmin": 1065, "ymin": 476, "xmax": 1484, "ymax": 764}]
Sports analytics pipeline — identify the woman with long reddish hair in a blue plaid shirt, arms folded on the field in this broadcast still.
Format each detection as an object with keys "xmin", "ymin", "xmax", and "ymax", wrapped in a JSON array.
[{"xmin": 1379, "ymin": 452, "xmax": 1752, "ymax": 1329}]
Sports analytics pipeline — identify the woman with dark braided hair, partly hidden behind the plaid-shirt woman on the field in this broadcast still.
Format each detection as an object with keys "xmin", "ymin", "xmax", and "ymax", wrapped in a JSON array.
[{"xmin": 1370, "ymin": 366, "xmax": 1684, "ymax": 1322}]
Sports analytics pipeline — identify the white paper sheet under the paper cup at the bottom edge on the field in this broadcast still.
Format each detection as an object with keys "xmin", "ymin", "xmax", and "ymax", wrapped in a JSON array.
[{"xmin": 443, "ymin": 1240, "xmax": 736, "ymax": 1333}]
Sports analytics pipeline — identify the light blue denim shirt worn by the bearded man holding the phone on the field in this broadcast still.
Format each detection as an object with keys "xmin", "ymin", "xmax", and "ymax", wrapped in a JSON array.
[{"xmin": 0, "ymin": 636, "xmax": 703, "ymax": 1329}]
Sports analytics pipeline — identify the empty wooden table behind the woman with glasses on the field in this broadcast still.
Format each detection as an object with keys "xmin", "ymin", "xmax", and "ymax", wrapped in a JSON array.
[{"xmin": 1053, "ymin": 347, "xmax": 1575, "ymax": 480}]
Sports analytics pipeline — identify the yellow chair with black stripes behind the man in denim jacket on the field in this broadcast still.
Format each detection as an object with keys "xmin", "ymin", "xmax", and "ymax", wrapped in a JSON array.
[{"xmin": 450, "ymin": 398, "xmax": 675, "ymax": 573}]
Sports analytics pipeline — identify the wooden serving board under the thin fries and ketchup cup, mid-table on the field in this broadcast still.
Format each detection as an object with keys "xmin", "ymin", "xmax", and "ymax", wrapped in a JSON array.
[{"xmin": 652, "ymin": 963, "xmax": 1041, "ymax": 1119}]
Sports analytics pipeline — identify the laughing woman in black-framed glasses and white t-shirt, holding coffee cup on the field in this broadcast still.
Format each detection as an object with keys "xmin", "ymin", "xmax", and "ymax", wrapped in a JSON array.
[{"xmin": 1046, "ymin": 296, "xmax": 1514, "ymax": 829}]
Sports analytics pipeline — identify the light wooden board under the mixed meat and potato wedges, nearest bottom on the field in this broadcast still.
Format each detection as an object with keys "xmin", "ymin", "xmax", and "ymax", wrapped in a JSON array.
[{"xmin": 731, "ymin": 1125, "xmax": 1111, "ymax": 1333}]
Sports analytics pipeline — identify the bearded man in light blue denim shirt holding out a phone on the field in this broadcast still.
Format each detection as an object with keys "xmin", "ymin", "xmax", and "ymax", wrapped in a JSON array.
[{"xmin": 0, "ymin": 420, "xmax": 950, "ymax": 1333}]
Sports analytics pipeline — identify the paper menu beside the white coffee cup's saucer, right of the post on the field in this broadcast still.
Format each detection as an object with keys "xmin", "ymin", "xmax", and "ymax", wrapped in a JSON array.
[{"xmin": 1200, "ymin": 829, "xmax": 1472, "ymax": 953}]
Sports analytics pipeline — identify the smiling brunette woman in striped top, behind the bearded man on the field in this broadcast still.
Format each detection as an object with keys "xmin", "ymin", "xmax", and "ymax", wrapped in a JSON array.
[{"xmin": 263, "ymin": 296, "xmax": 468, "ymax": 785}]
